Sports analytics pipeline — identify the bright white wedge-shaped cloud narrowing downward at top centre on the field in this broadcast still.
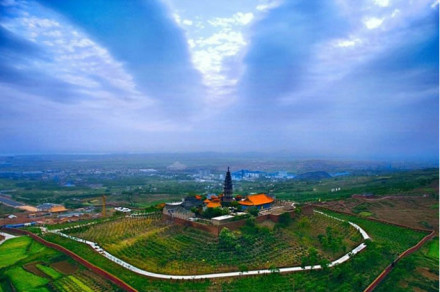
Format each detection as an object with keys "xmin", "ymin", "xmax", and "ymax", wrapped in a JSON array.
[{"xmin": 173, "ymin": 12, "xmax": 254, "ymax": 105}]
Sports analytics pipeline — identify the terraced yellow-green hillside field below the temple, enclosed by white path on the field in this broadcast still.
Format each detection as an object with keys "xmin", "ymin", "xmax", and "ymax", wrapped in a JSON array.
[{"xmin": 67, "ymin": 214, "xmax": 361, "ymax": 274}]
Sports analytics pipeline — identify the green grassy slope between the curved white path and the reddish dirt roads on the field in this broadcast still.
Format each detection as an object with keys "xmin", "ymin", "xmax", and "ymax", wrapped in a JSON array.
[{"xmin": 43, "ymin": 213, "xmax": 424, "ymax": 291}]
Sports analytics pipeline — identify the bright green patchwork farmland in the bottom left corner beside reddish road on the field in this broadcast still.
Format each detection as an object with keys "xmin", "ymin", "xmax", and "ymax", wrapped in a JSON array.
[{"xmin": 0, "ymin": 236, "xmax": 119, "ymax": 292}]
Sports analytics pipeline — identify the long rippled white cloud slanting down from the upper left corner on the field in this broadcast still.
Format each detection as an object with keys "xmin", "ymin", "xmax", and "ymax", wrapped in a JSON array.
[{"xmin": 1, "ymin": 0, "xmax": 147, "ymax": 103}]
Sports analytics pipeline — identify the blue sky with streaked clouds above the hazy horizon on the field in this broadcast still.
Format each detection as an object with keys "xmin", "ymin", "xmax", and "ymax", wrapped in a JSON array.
[{"xmin": 0, "ymin": 0, "xmax": 439, "ymax": 161}]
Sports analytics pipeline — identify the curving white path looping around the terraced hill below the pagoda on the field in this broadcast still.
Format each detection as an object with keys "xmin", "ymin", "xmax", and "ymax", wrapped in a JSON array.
[{"xmin": 49, "ymin": 210, "xmax": 370, "ymax": 280}]
